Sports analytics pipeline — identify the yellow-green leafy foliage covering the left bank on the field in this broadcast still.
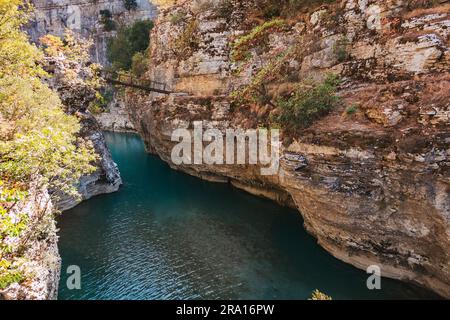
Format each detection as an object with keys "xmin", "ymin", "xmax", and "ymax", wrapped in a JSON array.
[{"xmin": 0, "ymin": 0, "xmax": 96, "ymax": 288}]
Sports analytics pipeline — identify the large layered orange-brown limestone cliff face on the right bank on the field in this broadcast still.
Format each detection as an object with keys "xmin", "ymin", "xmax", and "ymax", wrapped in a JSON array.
[{"xmin": 127, "ymin": 0, "xmax": 450, "ymax": 298}]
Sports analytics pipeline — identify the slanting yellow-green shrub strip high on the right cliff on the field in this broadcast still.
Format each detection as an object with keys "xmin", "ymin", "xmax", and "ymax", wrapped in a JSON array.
[{"xmin": 231, "ymin": 19, "xmax": 286, "ymax": 61}]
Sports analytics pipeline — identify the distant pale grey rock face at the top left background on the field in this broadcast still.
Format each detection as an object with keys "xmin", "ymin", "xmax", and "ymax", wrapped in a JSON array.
[{"xmin": 28, "ymin": 0, "xmax": 156, "ymax": 65}]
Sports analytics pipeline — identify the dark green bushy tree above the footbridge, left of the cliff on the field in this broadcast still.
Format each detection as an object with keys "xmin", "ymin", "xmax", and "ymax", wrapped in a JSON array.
[{"xmin": 107, "ymin": 20, "xmax": 153, "ymax": 71}]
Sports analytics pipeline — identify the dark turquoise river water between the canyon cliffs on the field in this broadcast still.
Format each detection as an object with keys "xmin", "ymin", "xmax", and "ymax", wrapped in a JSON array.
[{"xmin": 58, "ymin": 134, "xmax": 435, "ymax": 299}]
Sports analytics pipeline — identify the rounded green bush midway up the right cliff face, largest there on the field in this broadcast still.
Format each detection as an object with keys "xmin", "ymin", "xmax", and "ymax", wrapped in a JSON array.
[{"xmin": 278, "ymin": 75, "xmax": 340, "ymax": 129}]
